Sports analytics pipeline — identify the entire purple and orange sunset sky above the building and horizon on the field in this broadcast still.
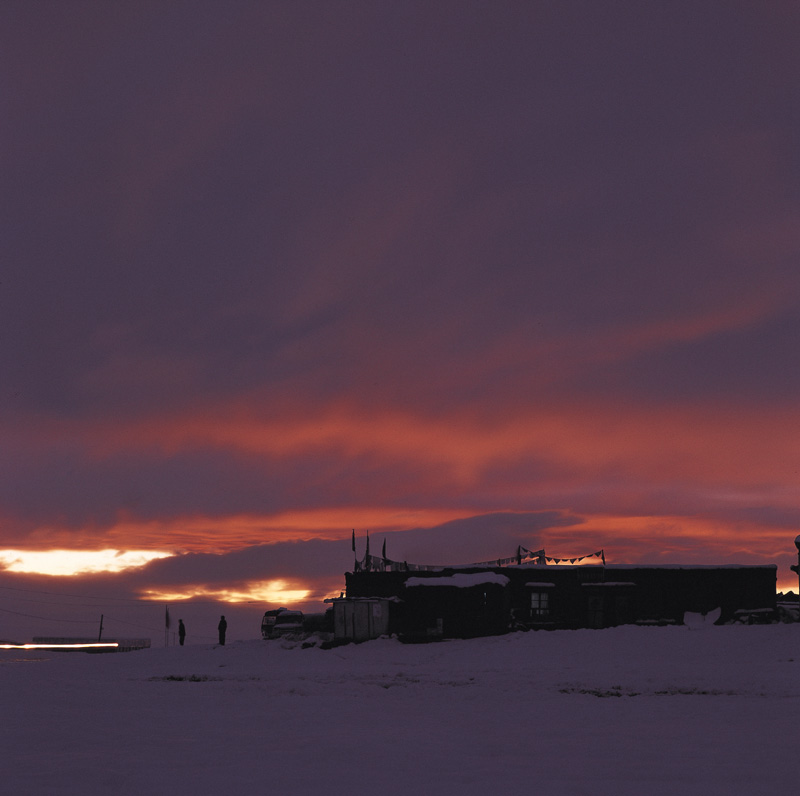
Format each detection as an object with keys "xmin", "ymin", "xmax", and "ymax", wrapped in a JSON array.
[{"xmin": 0, "ymin": 0, "xmax": 800, "ymax": 612}]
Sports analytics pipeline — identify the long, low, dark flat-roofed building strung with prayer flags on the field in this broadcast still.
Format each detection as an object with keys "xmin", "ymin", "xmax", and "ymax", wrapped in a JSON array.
[{"xmin": 340, "ymin": 551, "xmax": 777, "ymax": 640}]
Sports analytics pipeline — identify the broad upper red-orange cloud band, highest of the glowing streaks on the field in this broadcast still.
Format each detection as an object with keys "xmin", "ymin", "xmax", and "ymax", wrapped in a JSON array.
[{"xmin": 62, "ymin": 402, "xmax": 800, "ymax": 492}]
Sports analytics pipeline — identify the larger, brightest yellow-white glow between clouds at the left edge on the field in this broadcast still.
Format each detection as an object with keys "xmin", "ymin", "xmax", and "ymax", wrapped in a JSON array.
[{"xmin": 0, "ymin": 548, "xmax": 173, "ymax": 576}]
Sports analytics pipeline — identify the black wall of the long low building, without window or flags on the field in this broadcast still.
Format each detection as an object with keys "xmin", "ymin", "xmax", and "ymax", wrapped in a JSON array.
[{"xmin": 345, "ymin": 565, "xmax": 777, "ymax": 636}]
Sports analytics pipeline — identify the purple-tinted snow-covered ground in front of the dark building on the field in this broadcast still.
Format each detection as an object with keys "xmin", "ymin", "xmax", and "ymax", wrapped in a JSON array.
[{"xmin": 0, "ymin": 625, "xmax": 800, "ymax": 796}]
